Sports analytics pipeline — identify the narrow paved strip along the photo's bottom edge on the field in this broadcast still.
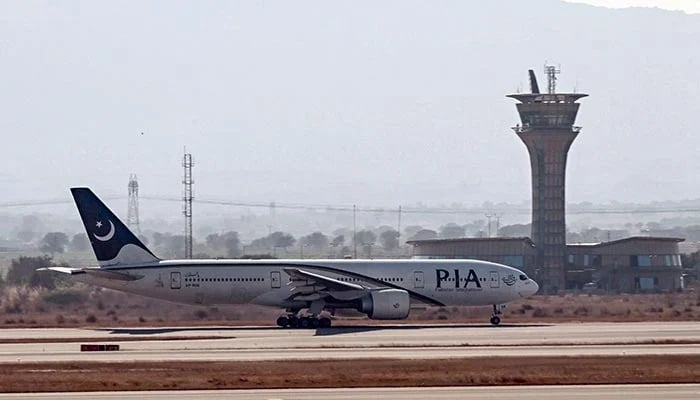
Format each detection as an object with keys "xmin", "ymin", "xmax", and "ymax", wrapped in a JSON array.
[{"xmin": 0, "ymin": 384, "xmax": 700, "ymax": 400}]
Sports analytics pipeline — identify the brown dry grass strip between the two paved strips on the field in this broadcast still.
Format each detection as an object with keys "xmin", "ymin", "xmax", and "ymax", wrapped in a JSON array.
[{"xmin": 0, "ymin": 356, "xmax": 700, "ymax": 392}]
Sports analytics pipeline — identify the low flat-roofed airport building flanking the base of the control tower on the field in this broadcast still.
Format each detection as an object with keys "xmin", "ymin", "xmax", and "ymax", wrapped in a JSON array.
[{"xmin": 407, "ymin": 236, "xmax": 683, "ymax": 293}]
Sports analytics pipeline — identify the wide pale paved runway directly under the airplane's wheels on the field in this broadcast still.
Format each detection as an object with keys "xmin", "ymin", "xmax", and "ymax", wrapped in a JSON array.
[{"xmin": 0, "ymin": 322, "xmax": 700, "ymax": 363}]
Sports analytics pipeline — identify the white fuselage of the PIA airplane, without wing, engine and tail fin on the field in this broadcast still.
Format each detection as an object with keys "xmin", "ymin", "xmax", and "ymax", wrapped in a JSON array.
[{"xmin": 80, "ymin": 260, "xmax": 523, "ymax": 307}]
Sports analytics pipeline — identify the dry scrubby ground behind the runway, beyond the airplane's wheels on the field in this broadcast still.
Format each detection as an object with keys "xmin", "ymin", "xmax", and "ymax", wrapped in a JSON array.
[{"xmin": 0, "ymin": 285, "xmax": 700, "ymax": 327}]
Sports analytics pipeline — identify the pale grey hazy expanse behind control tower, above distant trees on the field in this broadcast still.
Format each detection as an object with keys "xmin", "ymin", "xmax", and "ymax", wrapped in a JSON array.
[{"xmin": 0, "ymin": 0, "xmax": 700, "ymax": 212}]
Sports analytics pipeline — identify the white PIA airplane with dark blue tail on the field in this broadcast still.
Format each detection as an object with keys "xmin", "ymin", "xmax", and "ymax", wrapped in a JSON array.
[{"xmin": 42, "ymin": 187, "xmax": 539, "ymax": 328}]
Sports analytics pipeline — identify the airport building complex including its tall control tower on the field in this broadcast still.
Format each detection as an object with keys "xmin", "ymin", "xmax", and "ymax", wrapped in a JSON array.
[{"xmin": 407, "ymin": 66, "xmax": 683, "ymax": 294}]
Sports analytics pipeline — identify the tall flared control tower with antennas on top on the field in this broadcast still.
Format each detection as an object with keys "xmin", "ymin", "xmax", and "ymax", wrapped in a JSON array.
[{"xmin": 507, "ymin": 65, "xmax": 588, "ymax": 293}]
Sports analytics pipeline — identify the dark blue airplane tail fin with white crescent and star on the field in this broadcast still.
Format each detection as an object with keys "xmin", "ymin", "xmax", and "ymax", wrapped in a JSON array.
[{"xmin": 71, "ymin": 188, "xmax": 158, "ymax": 267}]
